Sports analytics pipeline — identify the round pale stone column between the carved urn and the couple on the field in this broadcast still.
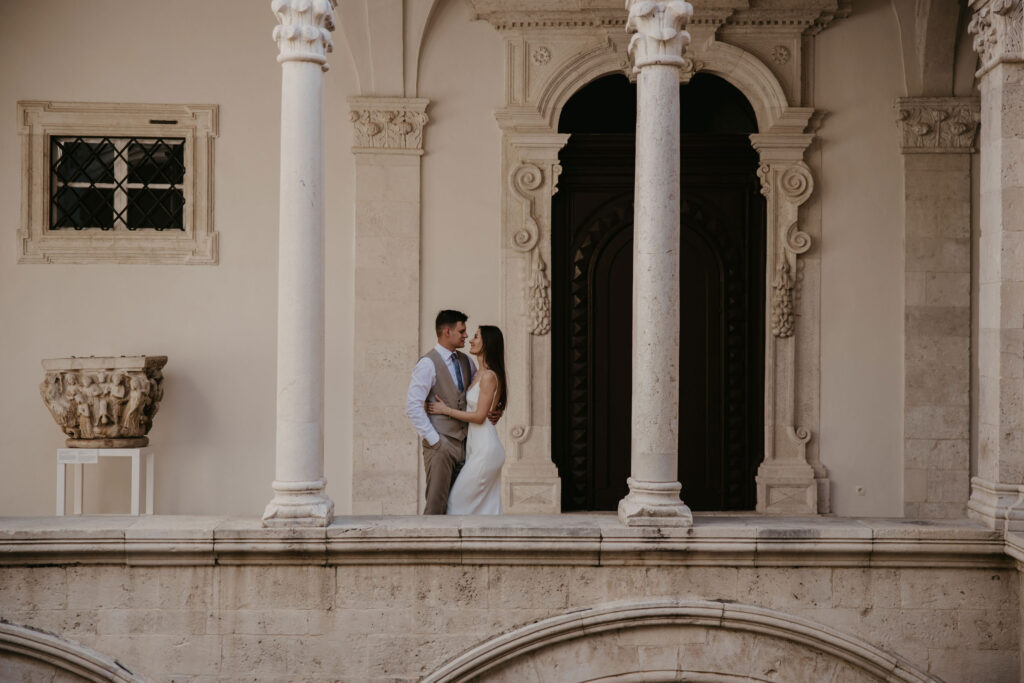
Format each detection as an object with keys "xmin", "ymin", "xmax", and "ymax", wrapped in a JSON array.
[{"xmin": 263, "ymin": 0, "xmax": 334, "ymax": 526}]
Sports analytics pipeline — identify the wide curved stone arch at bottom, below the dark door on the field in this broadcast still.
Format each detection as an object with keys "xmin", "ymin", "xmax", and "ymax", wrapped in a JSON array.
[{"xmin": 423, "ymin": 600, "xmax": 937, "ymax": 683}]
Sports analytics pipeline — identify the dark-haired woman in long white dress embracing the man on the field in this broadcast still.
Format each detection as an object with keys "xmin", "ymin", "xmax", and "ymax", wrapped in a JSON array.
[{"xmin": 427, "ymin": 325, "xmax": 508, "ymax": 515}]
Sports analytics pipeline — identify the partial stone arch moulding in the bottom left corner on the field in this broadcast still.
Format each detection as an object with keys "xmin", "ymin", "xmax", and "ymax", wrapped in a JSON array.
[{"xmin": 0, "ymin": 622, "xmax": 141, "ymax": 683}]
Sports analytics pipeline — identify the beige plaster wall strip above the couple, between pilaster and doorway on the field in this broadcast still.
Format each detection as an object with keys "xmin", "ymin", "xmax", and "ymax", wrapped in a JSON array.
[{"xmin": 419, "ymin": 0, "xmax": 501, "ymax": 344}]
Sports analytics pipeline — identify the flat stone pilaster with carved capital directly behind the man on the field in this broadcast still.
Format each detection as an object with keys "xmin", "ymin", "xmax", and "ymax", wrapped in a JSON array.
[{"xmin": 348, "ymin": 97, "xmax": 433, "ymax": 515}]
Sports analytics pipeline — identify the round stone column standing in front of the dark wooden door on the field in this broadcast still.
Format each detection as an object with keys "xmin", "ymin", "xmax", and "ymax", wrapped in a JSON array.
[{"xmin": 618, "ymin": 0, "xmax": 693, "ymax": 526}]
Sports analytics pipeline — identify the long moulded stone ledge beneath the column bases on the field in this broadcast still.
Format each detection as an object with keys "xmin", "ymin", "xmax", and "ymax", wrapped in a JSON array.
[{"xmin": 0, "ymin": 514, "xmax": 1007, "ymax": 568}]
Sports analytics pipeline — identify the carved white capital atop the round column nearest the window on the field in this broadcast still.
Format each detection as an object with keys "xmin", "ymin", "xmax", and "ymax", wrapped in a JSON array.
[{"xmin": 270, "ymin": 0, "xmax": 335, "ymax": 71}]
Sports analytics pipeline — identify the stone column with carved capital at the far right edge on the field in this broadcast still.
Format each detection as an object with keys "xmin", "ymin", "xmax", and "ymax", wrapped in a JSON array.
[{"xmin": 968, "ymin": 0, "xmax": 1024, "ymax": 530}]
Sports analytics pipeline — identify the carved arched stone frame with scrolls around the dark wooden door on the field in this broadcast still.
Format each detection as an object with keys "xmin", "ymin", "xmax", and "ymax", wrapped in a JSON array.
[{"xmin": 487, "ymin": 21, "xmax": 830, "ymax": 514}]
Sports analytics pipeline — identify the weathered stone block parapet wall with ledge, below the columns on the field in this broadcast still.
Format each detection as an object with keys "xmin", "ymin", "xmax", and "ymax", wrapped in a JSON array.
[{"xmin": 0, "ymin": 515, "xmax": 1020, "ymax": 682}]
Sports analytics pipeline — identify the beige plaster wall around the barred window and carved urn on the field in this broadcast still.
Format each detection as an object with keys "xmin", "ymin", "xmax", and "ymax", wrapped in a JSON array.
[{"xmin": 0, "ymin": 0, "xmax": 354, "ymax": 515}]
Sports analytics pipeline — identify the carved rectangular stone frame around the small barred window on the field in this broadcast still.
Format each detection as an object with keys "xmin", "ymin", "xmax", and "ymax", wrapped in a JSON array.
[{"xmin": 17, "ymin": 100, "xmax": 218, "ymax": 265}]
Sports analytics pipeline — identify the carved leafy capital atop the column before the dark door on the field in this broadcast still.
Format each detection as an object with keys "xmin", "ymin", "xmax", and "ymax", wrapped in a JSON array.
[{"xmin": 626, "ymin": 0, "xmax": 693, "ymax": 71}]
